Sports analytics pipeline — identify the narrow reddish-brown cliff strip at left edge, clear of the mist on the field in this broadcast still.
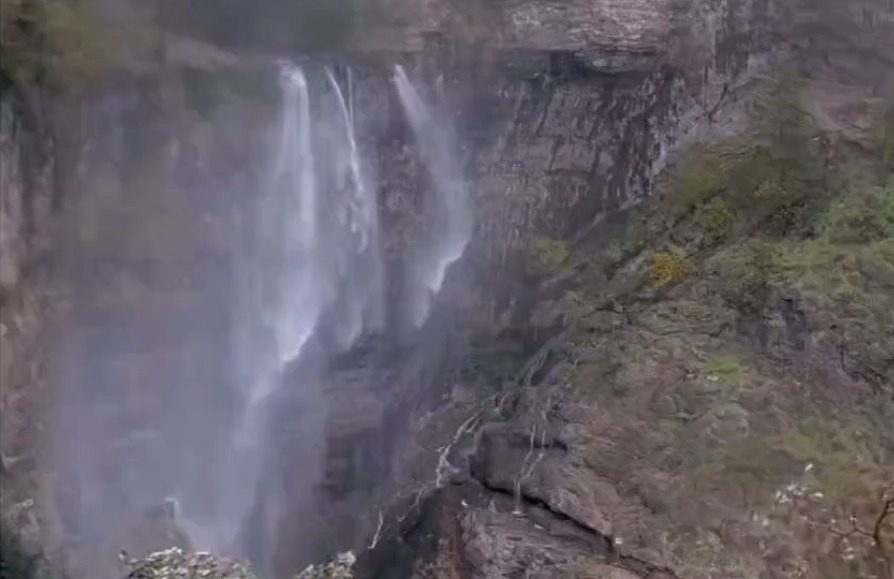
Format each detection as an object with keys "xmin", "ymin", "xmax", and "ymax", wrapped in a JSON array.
[{"xmin": 0, "ymin": 94, "xmax": 60, "ymax": 556}]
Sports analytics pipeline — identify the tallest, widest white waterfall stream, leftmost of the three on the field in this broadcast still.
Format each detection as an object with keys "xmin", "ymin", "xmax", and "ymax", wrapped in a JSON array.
[{"xmin": 176, "ymin": 65, "xmax": 331, "ymax": 549}]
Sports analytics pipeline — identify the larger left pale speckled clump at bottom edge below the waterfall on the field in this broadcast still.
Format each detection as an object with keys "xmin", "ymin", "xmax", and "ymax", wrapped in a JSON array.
[{"xmin": 122, "ymin": 547, "xmax": 257, "ymax": 579}]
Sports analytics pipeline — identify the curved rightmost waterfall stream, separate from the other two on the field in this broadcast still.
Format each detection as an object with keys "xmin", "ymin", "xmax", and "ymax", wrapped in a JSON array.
[{"xmin": 394, "ymin": 65, "xmax": 472, "ymax": 326}]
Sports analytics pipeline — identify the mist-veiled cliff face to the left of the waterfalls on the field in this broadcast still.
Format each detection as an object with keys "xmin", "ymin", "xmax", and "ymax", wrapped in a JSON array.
[{"xmin": 2, "ymin": 59, "xmax": 275, "ymax": 576}]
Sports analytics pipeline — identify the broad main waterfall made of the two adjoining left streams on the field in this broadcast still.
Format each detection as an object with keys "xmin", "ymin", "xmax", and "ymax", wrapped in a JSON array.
[{"xmin": 184, "ymin": 64, "xmax": 382, "ymax": 564}]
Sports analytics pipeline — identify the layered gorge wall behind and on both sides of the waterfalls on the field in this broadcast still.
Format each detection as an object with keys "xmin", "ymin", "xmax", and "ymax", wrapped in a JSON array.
[{"xmin": 2, "ymin": 1, "xmax": 894, "ymax": 577}]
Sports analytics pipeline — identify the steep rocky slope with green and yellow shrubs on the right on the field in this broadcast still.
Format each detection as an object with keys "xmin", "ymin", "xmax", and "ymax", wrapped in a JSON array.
[{"xmin": 360, "ymin": 85, "xmax": 894, "ymax": 579}]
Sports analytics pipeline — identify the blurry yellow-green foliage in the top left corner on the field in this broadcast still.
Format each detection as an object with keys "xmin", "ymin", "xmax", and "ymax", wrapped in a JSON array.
[{"xmin": 0, "ymin": 0, "xmax": 111, "ymax": 90}]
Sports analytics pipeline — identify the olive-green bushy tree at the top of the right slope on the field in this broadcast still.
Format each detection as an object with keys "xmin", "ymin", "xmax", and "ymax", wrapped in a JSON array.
[{"xmin": 664, "ymin": 83, "xmax": 827, "ymax": 241}]
